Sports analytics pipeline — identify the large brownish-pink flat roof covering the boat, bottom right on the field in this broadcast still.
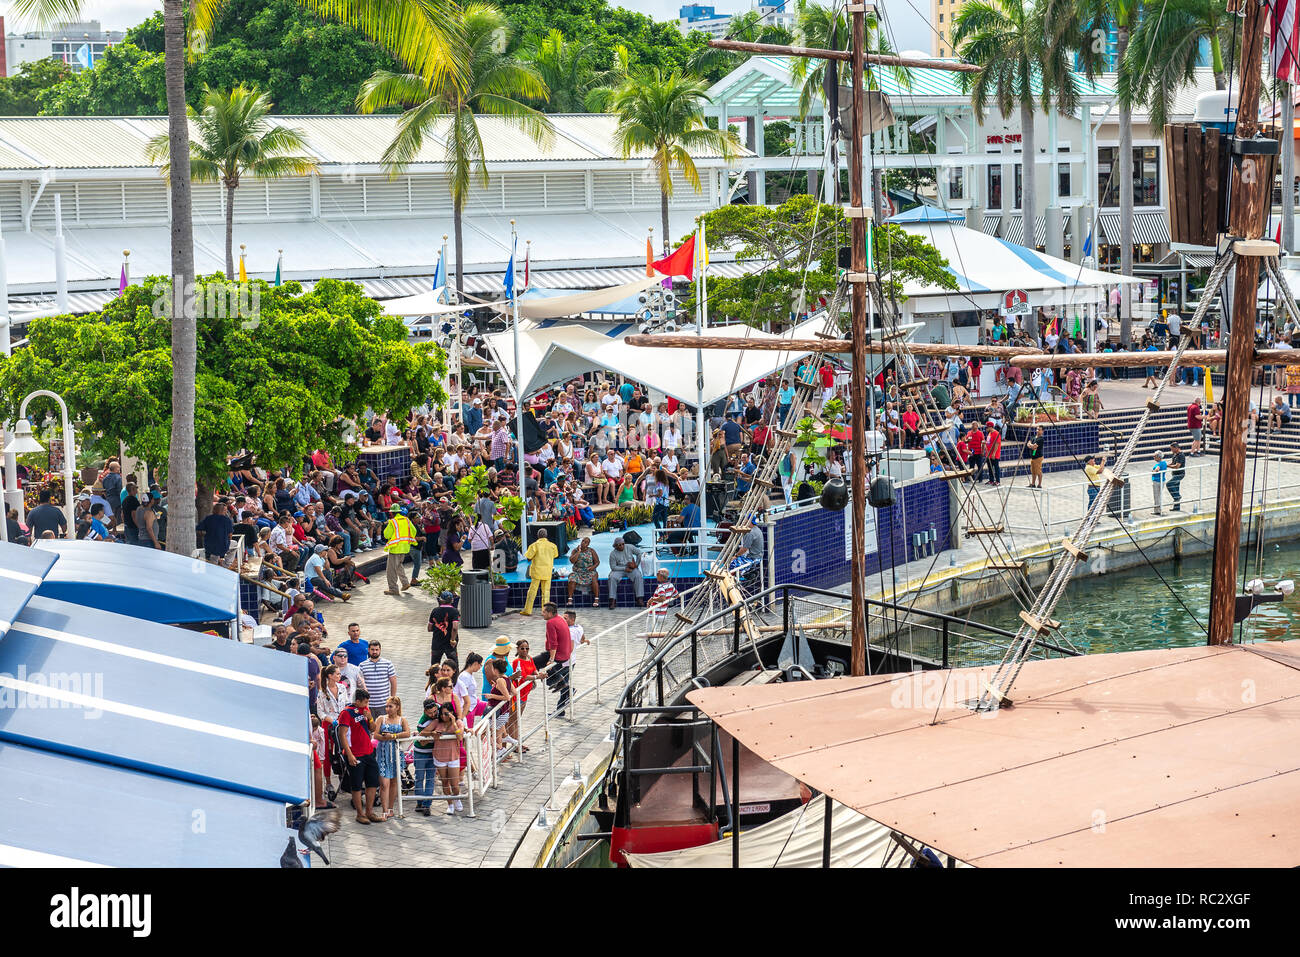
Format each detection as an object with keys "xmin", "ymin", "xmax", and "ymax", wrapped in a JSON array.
[{"xmin": 688, "ymin": 641, "xmax": 1300, "ymax": 867}]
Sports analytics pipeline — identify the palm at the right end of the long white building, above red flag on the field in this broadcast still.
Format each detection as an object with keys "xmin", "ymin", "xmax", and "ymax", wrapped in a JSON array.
[{"xmin": 610, "ymin": 68, "xmax": 741, "ymax": 247}]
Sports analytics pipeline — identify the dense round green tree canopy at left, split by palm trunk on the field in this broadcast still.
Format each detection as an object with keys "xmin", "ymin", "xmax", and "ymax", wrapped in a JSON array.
[{"xmin": 0, "ymin": 277, "xmax": 446, "ymax": 484}]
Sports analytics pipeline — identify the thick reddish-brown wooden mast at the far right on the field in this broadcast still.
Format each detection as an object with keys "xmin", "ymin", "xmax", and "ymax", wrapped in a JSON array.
[{"xmin": 1209, "ymin": 0, "xmax": 1268, "ymax": 645}]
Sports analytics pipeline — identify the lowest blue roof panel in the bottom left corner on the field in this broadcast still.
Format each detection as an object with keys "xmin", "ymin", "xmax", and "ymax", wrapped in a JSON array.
[{"xmin": 0, "ymin": 738, "xmax": 291, "ymax": 867}]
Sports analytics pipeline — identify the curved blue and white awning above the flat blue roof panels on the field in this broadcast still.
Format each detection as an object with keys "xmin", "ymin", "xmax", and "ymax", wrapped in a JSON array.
[{"xmin": 35, "ymin": 538, "xmax": 239, "ymax": 624}]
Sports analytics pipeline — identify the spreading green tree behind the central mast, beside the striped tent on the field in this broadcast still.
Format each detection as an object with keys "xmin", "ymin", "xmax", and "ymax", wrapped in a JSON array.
[{"xmin": 683, "ymin": 195, "xmax": 957, "ymax": 328}]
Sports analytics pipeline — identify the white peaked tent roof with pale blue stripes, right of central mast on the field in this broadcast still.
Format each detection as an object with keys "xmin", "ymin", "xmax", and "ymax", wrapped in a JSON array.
[{"xmin": 900, "ymin": 222, "xmax": 1143, "ymax": 312}]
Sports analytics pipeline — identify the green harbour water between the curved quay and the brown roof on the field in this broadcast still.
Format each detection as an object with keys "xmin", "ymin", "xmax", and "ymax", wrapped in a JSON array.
[{"xmin": 953, "ymin": 545, "xmax": 1300, "ymax": 664}]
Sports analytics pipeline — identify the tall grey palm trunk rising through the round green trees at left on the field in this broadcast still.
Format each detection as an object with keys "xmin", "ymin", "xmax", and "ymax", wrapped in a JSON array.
[{"xmin": 10, "ymin": 0, "xmax": 202, "ymax": 555}]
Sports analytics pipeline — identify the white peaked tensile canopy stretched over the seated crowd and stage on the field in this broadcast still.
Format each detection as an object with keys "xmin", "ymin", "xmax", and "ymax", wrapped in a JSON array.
[{"xmin": 485, "ymin": 316, "xmax": 826, "ymax": 406}]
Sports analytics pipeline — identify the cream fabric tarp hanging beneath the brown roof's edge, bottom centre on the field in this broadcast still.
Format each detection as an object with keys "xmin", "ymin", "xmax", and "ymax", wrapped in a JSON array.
[{"xmin": 627, "ymin": 794, "xmax": 911, "ymax": 867}]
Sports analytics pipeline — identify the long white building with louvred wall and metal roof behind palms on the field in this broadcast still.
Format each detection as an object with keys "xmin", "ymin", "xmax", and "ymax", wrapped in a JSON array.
[{"xmin": 0, "ymin": 108, "xmax": 754, "ymax": 319}]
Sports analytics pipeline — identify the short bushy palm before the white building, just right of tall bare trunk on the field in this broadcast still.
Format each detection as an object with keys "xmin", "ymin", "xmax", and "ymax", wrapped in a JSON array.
[{"xmin": 147, "ymin": 85, "xmax": 317, "ymax": 280}]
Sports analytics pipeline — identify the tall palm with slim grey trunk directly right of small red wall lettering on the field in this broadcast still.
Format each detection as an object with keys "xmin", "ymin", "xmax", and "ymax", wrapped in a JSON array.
[{"xmin": 953, "ymin": 0, "xmax": 1079, "ymax": 244}]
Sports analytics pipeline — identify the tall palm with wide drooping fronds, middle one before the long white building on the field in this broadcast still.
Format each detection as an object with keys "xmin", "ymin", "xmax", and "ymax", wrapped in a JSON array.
[{"xmin": 356, "ymin": 3, "xmax": 555, "ymax": 294}]
